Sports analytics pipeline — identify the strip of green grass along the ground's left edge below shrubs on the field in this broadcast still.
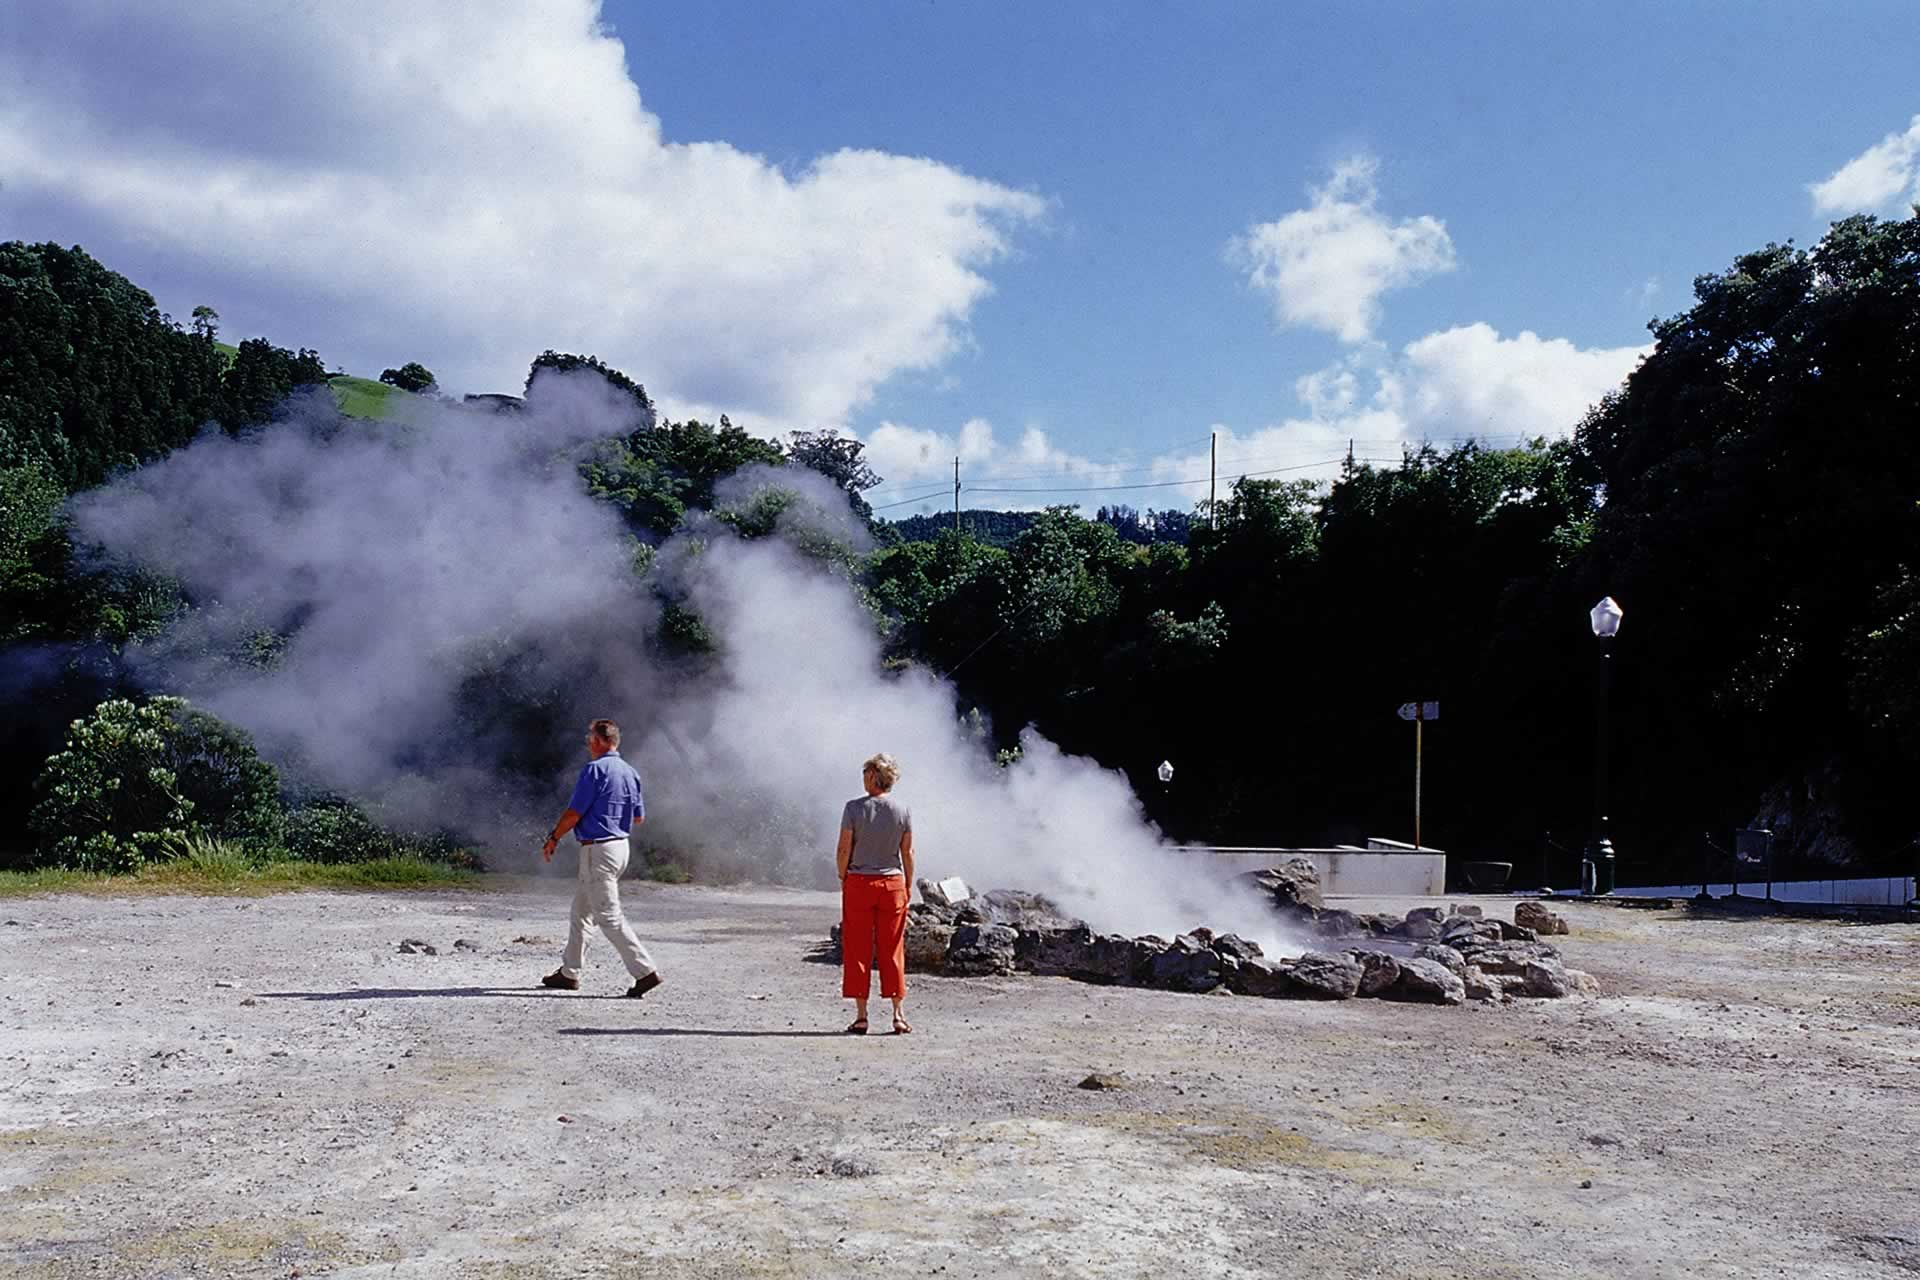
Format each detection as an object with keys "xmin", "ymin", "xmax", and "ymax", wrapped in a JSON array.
[{"xmin": 0, "ymin": 852, "xmax": 482, "ymax": 898}]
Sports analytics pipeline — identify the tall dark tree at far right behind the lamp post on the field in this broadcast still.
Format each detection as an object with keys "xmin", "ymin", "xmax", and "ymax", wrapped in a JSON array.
[{"xmin": 1580, "ymin": 215, "xmax": 1920, "ymax": 871}]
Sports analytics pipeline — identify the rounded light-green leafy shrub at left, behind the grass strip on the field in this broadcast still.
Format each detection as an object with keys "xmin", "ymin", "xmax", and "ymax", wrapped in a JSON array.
[{"xmin": 31, "ymin": 697, "xmax": 284, "ymax": 871}]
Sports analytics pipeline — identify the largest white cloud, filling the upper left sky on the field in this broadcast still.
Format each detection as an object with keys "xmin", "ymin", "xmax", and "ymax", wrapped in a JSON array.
[{"xmin": 0, "ymin": 0, "xmax": 1046, "ymax": 424}]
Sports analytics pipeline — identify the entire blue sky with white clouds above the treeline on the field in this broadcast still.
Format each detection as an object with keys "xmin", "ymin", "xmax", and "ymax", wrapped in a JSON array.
[{"xmin": 0, "ymin": 0, "xmax": 1920, "ymax": 514}]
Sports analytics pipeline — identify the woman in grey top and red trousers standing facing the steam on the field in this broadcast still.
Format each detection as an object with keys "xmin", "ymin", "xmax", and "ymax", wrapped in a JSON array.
[{"xmin": 837, "ymin": 752, "xmax": 914, "ymax": 1036}]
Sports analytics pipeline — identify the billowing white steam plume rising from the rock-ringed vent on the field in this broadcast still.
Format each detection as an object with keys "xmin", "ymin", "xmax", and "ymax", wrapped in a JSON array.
[{"xmin": 75, "ymin": 374, "xmax": 1279, "ymax": 946}]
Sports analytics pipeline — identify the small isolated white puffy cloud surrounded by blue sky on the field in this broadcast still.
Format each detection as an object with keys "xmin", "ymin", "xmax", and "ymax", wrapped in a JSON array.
[{"xmin": 1227, "ymin": 155, "xmax": 1453, "ymax": 342}]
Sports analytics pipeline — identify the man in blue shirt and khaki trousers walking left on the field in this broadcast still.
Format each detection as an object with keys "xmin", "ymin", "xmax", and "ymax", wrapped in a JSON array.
[{"xmin": 540, "ymin": 720, "xmax": 660, "ymax": 998}]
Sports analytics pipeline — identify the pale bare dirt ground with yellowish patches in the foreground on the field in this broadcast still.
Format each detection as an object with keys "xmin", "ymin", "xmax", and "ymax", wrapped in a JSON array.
[{"xmin": 0, "ymin": 881, "xmax": 1920, "ymax": 1280}]
